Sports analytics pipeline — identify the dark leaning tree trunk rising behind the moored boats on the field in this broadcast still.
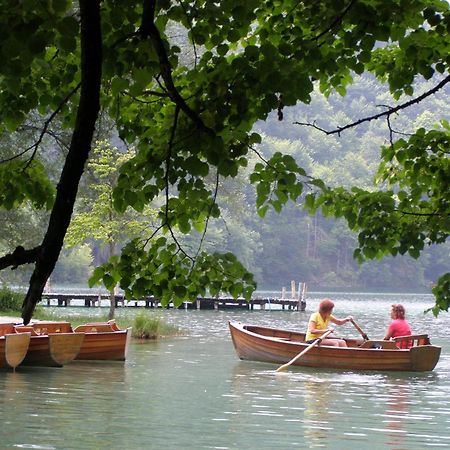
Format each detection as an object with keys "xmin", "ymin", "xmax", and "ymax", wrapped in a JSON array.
[{"xmin": 22, "ymin": 0, "xmax": 102, "ymax": 324}]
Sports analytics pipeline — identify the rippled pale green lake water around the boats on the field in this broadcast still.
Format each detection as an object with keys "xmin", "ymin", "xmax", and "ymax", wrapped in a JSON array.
[{"xmin": 0, "ymin": 294, "xmax": 450, "ymax": 450}]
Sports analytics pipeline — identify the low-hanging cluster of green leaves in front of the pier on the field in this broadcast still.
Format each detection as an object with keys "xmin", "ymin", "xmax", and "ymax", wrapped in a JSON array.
[{"xmin": 90, "ymin": 237, "xmax": 253, "ymax": 306}]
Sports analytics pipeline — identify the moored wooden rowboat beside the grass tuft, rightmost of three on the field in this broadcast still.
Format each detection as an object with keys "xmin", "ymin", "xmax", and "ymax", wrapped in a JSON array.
[{"xmin": 74, "ymin": 321, "xmax": 131, "ymax": 361}]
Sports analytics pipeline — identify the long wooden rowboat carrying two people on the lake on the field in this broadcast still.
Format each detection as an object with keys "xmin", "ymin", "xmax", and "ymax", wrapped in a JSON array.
[{"xmin": 229, "ymin": 322, "xmax": 441, "ymax": 372}]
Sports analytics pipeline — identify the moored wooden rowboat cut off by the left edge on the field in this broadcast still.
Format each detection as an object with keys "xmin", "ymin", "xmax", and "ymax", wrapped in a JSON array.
[{"xmin": 0, "ymin": 324, "xmax": 31, "ymax": 369}]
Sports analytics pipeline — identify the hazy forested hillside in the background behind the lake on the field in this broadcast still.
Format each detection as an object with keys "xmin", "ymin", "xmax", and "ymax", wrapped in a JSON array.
[{"xmin": 0, "ymin": 73, "xmax": 450, "ymax": 292}]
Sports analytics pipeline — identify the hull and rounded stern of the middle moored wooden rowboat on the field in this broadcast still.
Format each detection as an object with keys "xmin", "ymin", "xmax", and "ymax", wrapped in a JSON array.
[{"xmin": 22, "ymin": 333, "xmax": 84, "ymax": 367}]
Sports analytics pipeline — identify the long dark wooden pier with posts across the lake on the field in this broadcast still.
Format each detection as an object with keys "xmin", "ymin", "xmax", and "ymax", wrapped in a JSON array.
[{"xmin": 40, "ymin": 292, "xmax": 306, "ymax": 311}]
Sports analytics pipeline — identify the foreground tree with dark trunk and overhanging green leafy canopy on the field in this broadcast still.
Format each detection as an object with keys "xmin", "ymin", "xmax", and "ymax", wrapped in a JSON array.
[{"xmin": 0, "ymin": 0, "xmax": 450, "ymax": 320}]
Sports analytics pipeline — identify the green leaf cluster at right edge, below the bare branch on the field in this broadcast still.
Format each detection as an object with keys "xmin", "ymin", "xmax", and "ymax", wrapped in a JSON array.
[{"xmin": 307, "ymin": 122, "xmax": 450, "ymax": 298}]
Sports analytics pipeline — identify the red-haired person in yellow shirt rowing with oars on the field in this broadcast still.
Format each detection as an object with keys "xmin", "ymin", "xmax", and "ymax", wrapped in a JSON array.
[{"xmin": 305, "ymin": 298, "xmax": 353, "ymax": 347}]
